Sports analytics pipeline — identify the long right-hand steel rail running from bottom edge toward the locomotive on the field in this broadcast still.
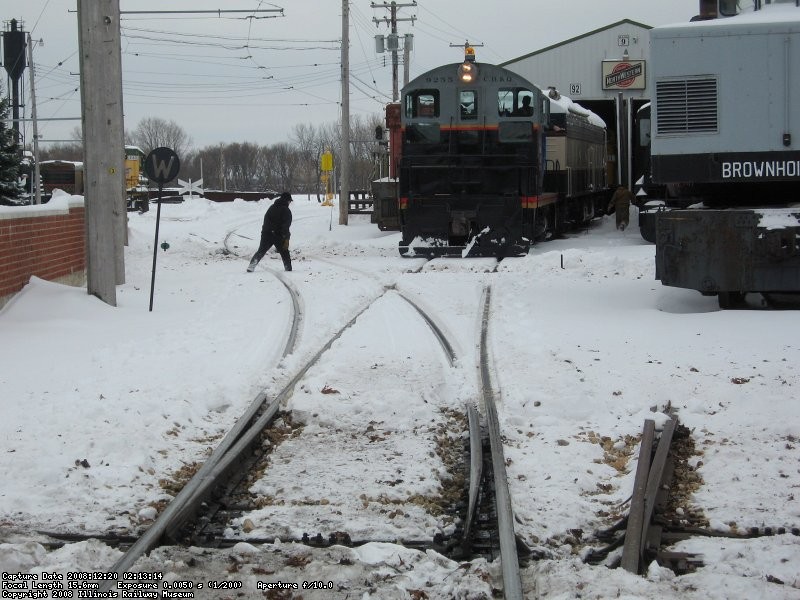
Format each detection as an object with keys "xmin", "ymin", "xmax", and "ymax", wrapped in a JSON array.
[{"xmin": 480, "ymin": 286, "xmax": 523, "ymax": 600}]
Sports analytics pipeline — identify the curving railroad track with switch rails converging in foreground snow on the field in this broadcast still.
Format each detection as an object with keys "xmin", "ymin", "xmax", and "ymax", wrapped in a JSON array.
[{"xmin": 94, "ymin": 244, "xmax": 522, "ymax": 598}]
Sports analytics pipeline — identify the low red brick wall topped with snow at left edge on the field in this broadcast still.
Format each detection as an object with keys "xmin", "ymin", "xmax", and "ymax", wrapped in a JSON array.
[{"xmin": 0, "ymin": 195, "xmax": 86, "ymax": 307}]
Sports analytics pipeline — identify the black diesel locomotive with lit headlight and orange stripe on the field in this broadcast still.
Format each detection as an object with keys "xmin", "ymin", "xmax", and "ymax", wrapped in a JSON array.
[{"xmin": 387, "ymin": 46, "xmax": 609, "ymax": 258}]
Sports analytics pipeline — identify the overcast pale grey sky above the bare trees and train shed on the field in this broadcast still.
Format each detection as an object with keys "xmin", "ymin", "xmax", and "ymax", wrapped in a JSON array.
[{"xmin": 2, "ymin": 0, "xmax": 698, "ymax": 148}]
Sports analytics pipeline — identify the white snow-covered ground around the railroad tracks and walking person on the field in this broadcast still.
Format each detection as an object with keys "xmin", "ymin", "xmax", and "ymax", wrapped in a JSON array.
[{"xmin": 0, "ymin": 196, "xmax": 800, "ymax": 599}]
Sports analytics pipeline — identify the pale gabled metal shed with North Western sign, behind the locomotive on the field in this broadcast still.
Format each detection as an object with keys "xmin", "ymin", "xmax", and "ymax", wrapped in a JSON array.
[{"xmin": 502, "ymin": 19, "xmax": 652, "ymax": 189}]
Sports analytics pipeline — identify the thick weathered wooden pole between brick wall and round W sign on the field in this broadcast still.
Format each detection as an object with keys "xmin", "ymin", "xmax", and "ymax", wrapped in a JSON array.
[{"xmin": 78, "ymin": 0, "xmax": 127, "ymax": 306}]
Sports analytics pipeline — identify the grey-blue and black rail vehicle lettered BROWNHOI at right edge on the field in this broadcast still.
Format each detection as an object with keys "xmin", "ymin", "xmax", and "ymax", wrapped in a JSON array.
[{"xmin": 650, "ymin": 0, "xmax": 800, "ymax": 308}]
